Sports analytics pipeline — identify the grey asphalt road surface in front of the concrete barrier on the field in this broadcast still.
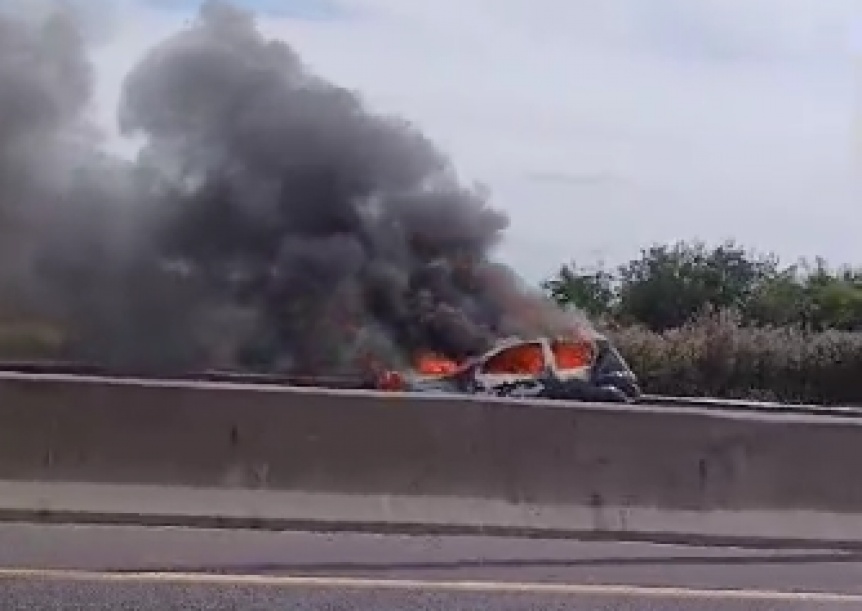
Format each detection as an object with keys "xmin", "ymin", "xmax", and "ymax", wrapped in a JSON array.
[{"xmin": 0, "ymin": 525, "xmax": 862, "ymax": 611}]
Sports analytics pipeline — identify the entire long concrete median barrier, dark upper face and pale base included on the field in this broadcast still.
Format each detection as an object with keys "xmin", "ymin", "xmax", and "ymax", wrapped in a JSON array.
[{"xmin": 0, "ymin": 374, "xmax": 862, "ymax": 545}]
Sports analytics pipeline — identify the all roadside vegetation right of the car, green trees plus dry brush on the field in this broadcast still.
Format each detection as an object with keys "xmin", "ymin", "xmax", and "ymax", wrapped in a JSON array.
[{"xmin": 543, "ymin": 242, "xmax": 862, "ymax": 404}]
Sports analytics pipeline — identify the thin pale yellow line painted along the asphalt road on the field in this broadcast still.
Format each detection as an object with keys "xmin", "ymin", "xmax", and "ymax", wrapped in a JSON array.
[{"xmin": 0, "ymin": 569, "xmax": 862, "ymax": 607}]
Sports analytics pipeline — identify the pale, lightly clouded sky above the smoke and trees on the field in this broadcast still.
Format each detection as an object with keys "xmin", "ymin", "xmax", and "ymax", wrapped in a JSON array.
[{"xmin": 28, "ymin": 0, "xmax": 862, "ymax": 279}]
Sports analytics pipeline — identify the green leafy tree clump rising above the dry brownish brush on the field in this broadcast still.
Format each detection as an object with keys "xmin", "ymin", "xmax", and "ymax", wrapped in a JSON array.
[{"xmin": 543, "ymin": 242, "xmax": 862, "ymax": 331}]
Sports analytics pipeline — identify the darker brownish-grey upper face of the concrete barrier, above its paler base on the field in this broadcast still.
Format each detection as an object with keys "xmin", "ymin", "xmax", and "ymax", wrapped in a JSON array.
[{"xmin": 5, "ymin": 374, "xmax": 862, "ymax": 511}]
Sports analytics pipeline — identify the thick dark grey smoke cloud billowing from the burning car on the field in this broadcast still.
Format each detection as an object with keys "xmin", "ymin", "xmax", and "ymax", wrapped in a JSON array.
[{"xmin": 0, "ymin": 2, "xmax": 592, "ymax": 373}]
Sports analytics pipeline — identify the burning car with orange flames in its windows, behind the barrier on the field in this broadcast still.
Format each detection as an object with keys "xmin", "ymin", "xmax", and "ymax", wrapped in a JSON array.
[{"xmin": 379, "ymin": 336, "xmax": 641, "ymax": 403}]
